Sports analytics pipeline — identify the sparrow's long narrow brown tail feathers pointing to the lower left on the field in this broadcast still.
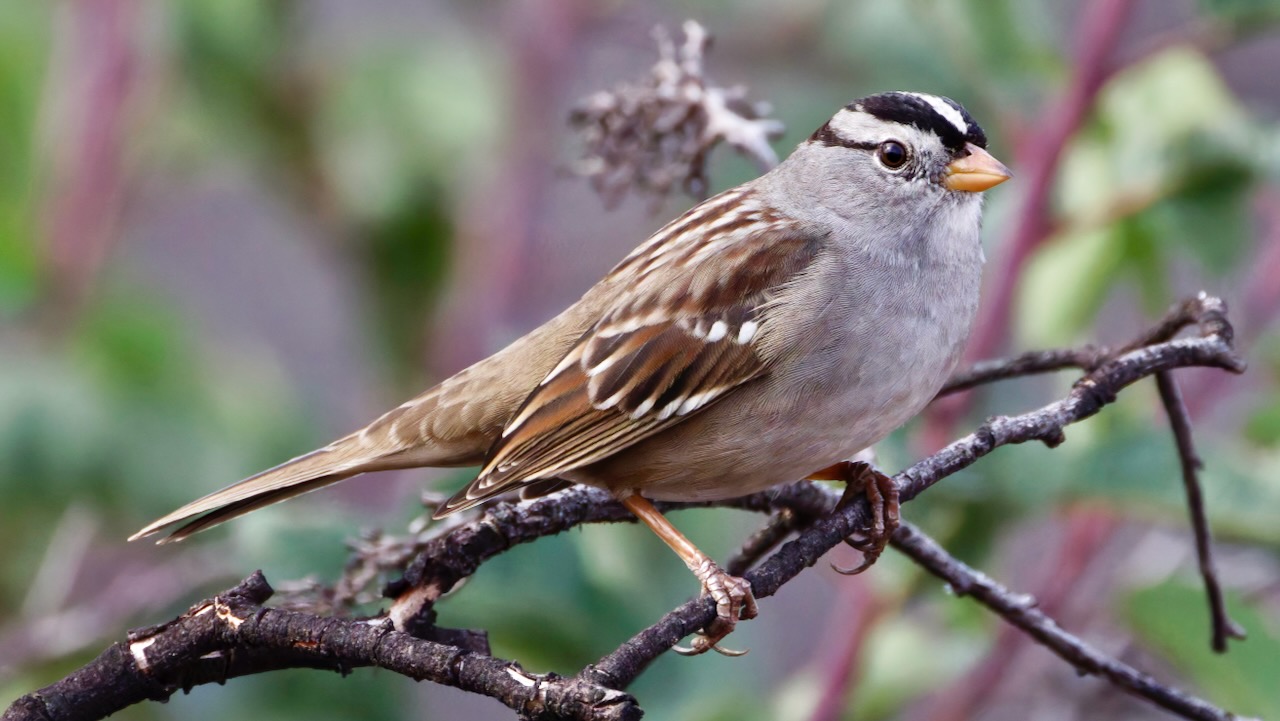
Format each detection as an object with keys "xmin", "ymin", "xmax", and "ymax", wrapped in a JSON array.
[{"xmin": 129, "ymin": 442, "xmax": 378, "ymax": 543}]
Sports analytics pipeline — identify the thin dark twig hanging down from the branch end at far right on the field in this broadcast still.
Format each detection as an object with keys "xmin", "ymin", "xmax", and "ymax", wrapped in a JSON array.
[{"xmin": 1156, "ymin": 370, "xmax": 1245, "ymax": 653}]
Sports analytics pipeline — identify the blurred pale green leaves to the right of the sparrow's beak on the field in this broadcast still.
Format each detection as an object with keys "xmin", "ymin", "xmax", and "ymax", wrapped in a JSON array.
[{"xmin": 1018, "ymin": 47, "xmax": 1265, "ymax": 344}]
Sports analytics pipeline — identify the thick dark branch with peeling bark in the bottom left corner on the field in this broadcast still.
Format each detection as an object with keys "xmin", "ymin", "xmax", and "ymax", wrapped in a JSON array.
[{"xmin": 4, "ymin": 572, "xmax": 641, "ymax": 721}]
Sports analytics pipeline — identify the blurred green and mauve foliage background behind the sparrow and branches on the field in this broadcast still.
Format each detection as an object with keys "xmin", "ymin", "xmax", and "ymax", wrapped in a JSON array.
[{"xmin": 0, "ymin": 0, "xmax": 1280, "ymax": 721}]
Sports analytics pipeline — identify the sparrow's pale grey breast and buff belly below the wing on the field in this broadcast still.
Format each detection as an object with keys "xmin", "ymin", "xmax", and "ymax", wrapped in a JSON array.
[{"xmin": 566, "ymin": 247, "xmax": 980, "ymax": 502}]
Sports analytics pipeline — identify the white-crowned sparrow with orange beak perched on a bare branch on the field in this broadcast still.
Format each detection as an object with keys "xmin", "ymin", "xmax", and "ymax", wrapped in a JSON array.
[{"xmin": 133, "ymin": 92, "xmax": 1009, "ymax": 651}]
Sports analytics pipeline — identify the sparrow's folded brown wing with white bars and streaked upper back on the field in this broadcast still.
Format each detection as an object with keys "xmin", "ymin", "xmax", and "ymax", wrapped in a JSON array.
[{"xmin": 436, "ymin": 198, "xmax": 820, "ymax": 516}]
